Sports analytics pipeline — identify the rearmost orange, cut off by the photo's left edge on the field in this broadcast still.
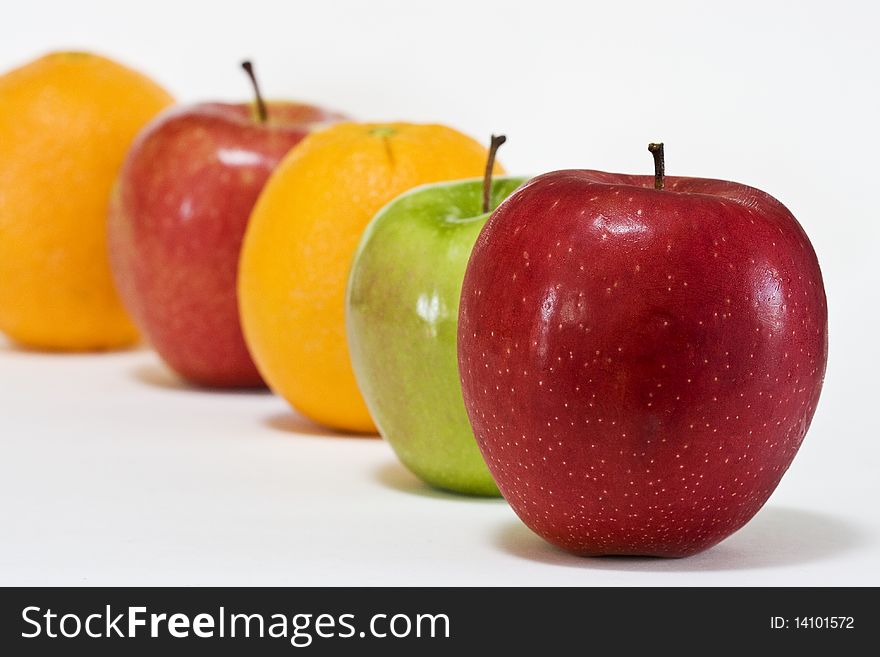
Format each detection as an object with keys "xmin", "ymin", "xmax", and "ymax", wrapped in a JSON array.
[{"xmin": 0, "ymin": 52, "xmax": 172, "ymax": 350}]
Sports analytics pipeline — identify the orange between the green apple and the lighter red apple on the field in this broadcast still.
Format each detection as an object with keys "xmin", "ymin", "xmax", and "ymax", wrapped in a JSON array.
[{"xmin": 238, "ymin": 123, "xmax": 500, "ymax": 433}]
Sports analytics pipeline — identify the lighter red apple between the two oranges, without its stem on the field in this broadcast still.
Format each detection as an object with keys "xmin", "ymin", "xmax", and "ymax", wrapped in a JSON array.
[{"xmin": 109, "ymin": 103, "xmax": 342, "ymax": 387}]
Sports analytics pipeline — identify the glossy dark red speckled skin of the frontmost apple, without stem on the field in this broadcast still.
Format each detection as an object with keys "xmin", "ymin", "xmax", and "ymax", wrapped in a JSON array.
[{"xmin": 458, "ymin": 170, "xmax": 827, "ymax": 557}]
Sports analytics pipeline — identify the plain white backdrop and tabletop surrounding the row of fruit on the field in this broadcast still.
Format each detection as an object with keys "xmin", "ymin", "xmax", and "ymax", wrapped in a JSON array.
[{"xmin": 0, "ymin": 0, "xmax": 880, "ymax": 585}]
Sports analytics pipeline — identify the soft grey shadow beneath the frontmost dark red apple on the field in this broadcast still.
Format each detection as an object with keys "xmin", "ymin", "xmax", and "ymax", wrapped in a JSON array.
[{"xmin": 495, "ymin": 507, "xmax": 866, "ymax": 572}]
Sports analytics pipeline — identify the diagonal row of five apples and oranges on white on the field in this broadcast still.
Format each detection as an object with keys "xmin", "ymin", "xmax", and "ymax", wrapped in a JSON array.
[{"xmin": 0, "ymin": 53, "xmax": 827, "ymax": 556}]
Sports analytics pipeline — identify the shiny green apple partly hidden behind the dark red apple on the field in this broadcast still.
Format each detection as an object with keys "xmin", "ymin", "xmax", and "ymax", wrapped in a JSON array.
[{"xmin": 346, "ymin": 177, "xmax": 526, "ymax": 495}]
